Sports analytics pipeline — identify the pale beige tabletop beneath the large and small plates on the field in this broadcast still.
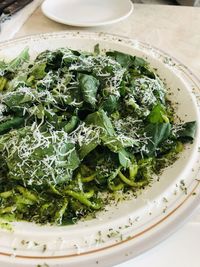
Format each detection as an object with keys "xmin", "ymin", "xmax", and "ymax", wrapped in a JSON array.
[{"xmin": 1, "ymin": 4, "xmax": 200, "ymax": 267}]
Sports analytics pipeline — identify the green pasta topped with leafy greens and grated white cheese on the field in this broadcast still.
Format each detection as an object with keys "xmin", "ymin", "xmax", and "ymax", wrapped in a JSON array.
[{"xmin": 0, "ymin": 45, "xmax": 196, "ymax": 225}]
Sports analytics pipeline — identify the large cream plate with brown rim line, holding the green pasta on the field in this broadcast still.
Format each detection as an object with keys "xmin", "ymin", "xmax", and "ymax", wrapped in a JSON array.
[{"xmin": 0, "ymin": 31, "xmax": 200, "ymax": 267}]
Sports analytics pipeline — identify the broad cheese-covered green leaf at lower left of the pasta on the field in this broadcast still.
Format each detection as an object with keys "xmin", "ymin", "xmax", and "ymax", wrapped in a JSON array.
[{"xmin": 4, "ymin": 130, "xmax": 80, "ymax": 187}]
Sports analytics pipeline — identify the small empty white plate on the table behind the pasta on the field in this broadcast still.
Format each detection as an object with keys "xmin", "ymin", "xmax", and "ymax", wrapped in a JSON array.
[{"xmin": 42, "ymin": 0, "xmax": 133, "ymax": 27}]
